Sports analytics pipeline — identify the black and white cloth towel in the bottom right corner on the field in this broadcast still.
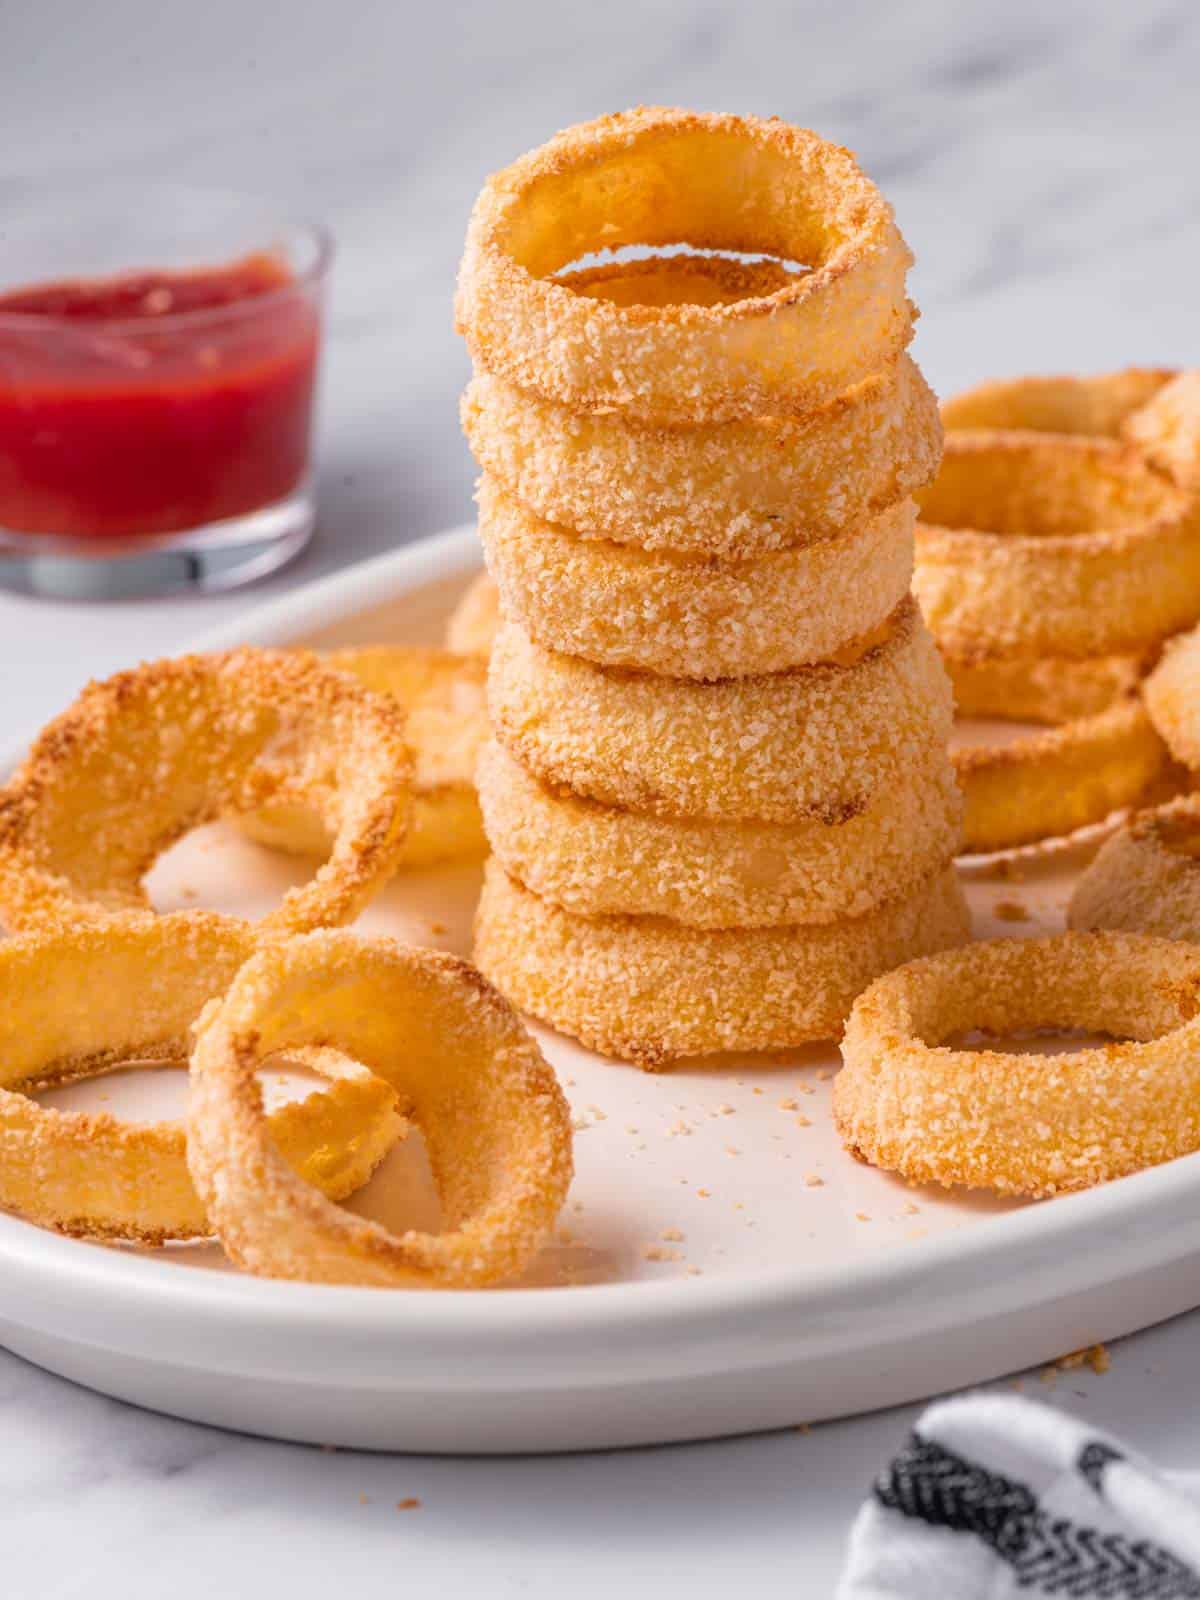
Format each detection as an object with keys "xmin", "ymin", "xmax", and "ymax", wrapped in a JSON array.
[{"xmin": 838, "ymin": 1395, "xmax": 1200, "ymax": 1600}]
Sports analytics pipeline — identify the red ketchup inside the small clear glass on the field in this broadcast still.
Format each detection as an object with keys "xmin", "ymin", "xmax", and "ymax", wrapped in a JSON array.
[{"xmin": 0, "ymin": 254, "xmax": 320, "ymax": 539}]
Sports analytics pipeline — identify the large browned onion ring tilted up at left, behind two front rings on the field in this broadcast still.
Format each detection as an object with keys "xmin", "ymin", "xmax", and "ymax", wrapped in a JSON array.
[{"xmin": 0, "ymin": 650, "xmax": 413, "ymax": 934}]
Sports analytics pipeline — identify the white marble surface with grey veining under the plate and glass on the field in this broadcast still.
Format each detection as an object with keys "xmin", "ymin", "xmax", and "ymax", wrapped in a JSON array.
[{"xmin": 0, "ymin": 0, "xmax": 1200, "ymax": 1600}]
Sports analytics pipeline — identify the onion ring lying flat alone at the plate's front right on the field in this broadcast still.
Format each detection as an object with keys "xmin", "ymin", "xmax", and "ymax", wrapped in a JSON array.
[{"xmin": 834, "ymin": 933, "xmax": 1200, "ymax": 1195}]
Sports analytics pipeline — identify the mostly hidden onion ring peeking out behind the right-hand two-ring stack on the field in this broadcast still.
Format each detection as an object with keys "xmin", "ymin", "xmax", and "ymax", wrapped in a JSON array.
[{"xmin": 942, "ymin": 366, "xmax": 1174, "ymax": 438}]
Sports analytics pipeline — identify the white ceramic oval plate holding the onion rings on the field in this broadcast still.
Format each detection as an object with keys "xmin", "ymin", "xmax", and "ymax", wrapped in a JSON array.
[{"xmin": 0, "ymin": 528, "xmax": 1200, "ymax": 1451}]
